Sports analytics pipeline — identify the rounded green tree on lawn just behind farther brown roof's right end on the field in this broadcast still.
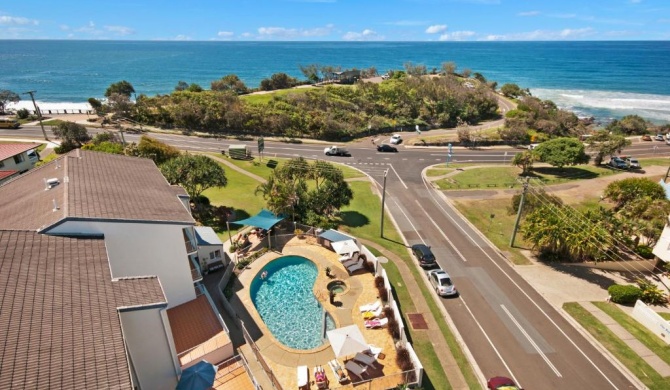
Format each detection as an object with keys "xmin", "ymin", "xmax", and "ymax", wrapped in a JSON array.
[{"xmin": 160, "ymin": 153, "xmax": 228, "ymax": 202}]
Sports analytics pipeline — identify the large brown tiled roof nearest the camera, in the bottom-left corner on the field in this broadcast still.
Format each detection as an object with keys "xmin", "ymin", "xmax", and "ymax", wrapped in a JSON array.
[{"xmin": 0, "ymin": 231, "xmax": 165, "ymax": 389}]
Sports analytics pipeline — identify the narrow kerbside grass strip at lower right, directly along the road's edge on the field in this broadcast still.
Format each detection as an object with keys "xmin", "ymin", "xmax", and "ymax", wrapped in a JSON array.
[{"xmin": 563, "ymin": 302, "xmax": 670, "ymax": 390}]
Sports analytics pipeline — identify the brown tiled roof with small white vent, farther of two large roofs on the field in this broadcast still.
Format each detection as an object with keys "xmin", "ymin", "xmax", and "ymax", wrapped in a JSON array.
[{"xmin": 0, "ymin": 150, "xmax": 194, "ymax": 230}]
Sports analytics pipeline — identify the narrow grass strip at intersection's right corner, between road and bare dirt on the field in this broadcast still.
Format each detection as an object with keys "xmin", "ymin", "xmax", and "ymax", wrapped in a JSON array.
[{"xmin": 435, "ymin": 165, "xmax": 617, "ymax": 190}]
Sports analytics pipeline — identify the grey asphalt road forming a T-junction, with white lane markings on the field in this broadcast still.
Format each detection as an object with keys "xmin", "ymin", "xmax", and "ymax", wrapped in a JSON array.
[{"xmin": 0, "ymin": 122, "xmax": 670, "ymax": 389}]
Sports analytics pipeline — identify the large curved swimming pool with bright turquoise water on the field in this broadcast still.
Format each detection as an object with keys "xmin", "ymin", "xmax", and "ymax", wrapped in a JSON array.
[{"xmin": 250, "ymin": 256, "xmax": 335, "ymax": 350}]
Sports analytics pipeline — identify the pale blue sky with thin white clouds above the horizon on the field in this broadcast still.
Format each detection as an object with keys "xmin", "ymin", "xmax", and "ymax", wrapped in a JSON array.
[{"xmin": 0, "ymin": 0, "xmax": 670, "ymax": 41}]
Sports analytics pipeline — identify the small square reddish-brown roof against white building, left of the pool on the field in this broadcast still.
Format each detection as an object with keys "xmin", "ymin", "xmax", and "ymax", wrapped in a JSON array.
[{"xmin": 167, "ymin": 295, "xmax": 223, "ymax": 354}]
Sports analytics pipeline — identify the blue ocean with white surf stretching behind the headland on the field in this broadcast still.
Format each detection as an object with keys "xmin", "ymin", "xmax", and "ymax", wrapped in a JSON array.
[{"xmin": 0, "ymin": 40, "xmax": 670, "ymax": 123}]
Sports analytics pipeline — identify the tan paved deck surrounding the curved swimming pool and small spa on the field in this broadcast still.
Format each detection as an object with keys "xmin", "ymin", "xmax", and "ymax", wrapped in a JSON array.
[{"xmin": 236, "ymin": 238, "xmax": 400, "ymax": 389}]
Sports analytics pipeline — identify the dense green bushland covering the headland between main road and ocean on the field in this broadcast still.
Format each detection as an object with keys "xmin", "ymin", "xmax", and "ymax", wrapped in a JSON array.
[{"xmin": 97, "ymin": 71, "xmax": 498, "ymax": 140}]
